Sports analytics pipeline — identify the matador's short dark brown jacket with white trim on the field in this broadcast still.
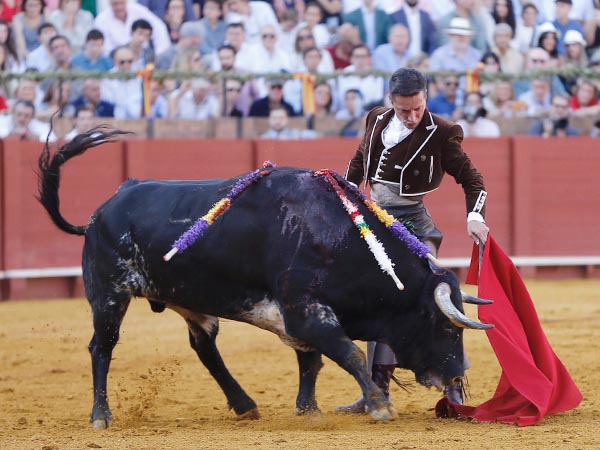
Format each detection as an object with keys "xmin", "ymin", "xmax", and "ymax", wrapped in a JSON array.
[{"xmin": 346, "ymin": 107, "xmax": 485, "ymax": 215}]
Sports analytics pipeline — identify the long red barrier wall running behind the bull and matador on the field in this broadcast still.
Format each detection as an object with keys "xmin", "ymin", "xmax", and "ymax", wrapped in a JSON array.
[{"xmin": 0, "ymin": 136, "xmax": 600, "ymax": 299}]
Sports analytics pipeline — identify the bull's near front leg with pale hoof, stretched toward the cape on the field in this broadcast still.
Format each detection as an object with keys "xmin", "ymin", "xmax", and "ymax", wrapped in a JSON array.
[{"xmin": 284, "ymin": 303, "xmax": 396, "ymax": 420}]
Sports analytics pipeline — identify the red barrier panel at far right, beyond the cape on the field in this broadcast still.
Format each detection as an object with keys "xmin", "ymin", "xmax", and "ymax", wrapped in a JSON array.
[{"xmin": 513, "ymin": 136, "xmax": 600, "ymax": 255}]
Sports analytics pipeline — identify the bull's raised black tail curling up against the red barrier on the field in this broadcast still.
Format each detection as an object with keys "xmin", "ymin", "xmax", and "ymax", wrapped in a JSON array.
[{"xmin": 38, "ymin": 126, "xmax": 129, "ymax": 236}]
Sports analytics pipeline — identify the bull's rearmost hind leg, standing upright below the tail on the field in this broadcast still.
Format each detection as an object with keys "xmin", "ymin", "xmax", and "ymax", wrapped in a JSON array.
[{"xmin": 88, "ymin": 294, "xmax": 131, "ymax": 429}]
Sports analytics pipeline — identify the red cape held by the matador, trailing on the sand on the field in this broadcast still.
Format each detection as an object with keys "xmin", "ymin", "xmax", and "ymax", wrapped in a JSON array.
[{"xmin": 436, "ymin": 236, "xmax": 583, "ymax": 426}]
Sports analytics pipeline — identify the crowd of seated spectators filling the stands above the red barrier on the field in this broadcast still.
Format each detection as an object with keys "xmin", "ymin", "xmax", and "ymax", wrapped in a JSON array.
[{"xmin": 0, "ymin": 0, "xmax": 600, "ymax": 140}]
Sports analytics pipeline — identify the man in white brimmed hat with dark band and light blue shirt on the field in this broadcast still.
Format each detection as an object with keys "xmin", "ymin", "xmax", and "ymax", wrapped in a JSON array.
[{"xmin": 429, "ymin": 17, "xmax": 481, "ymax": 72}]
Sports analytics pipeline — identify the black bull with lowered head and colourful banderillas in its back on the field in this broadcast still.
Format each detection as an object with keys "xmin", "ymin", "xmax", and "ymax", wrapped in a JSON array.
[{"xmin": 39, "ymin": 129, "xmax": 487, "ymax": 428}]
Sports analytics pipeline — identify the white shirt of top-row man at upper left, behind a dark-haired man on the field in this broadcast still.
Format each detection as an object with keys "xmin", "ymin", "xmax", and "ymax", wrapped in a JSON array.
[{"xmin": 94, "ymin": 3, "xmax": 171, "ymax": 55}]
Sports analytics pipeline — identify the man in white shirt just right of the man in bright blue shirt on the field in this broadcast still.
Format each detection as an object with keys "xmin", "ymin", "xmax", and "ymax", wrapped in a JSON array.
[{"xmin": 100, "ymin": 46, "xmax": 142, "ymax": 119}]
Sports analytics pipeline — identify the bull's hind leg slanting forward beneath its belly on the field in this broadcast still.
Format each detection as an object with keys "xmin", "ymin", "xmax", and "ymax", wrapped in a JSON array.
[{"xmin": 186, "ymin": 316, "xmax": 259, "ymax": 419}]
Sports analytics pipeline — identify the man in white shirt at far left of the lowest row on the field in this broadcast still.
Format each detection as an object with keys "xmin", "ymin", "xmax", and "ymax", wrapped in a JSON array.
[{"xmin": 0, "ymin": 100, "xmax": 56, "ymax": 142}]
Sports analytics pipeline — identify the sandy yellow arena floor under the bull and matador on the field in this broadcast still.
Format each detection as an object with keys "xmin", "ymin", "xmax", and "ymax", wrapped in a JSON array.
[{"xmin": 0, "ymin": 280, "xmax": 600, "ymax": 450}]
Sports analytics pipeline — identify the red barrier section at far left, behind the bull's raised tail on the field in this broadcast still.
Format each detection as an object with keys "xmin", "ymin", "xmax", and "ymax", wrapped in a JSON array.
[{"xmin": 1, "ymin": 139, "xmax": 124, "ymax": 297}]
